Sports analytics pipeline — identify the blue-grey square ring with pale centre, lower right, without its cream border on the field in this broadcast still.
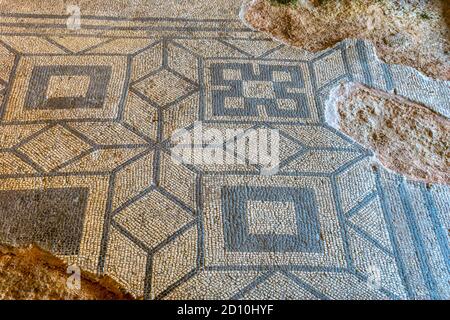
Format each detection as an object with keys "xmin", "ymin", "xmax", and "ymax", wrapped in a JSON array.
[{"xmin": 221, "ymin": 186, "xmax": 322, "ymax": 252}]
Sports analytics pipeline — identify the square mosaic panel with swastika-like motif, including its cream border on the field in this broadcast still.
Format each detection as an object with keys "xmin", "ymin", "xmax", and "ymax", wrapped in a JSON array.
[{"xmin": 204, "ymin": 59, "xmax": 318, "ymax": 122}]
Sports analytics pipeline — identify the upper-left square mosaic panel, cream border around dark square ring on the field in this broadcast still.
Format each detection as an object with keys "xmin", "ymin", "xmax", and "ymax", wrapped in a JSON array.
[{"xmin": 3, "ymin": 56, "xmax": 128, "ymax": 122}]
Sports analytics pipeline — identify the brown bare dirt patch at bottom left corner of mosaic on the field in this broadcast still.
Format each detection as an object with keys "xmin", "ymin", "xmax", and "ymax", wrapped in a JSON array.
[{"xmin": 0, "ymin": 245, "xmax": 133, "ymax": 300}]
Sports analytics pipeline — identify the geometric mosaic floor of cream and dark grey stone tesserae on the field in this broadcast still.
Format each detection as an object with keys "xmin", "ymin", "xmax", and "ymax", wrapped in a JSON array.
[{"xmin": 0, "ymin": 1, "xmax": 450, "ymax": 299}]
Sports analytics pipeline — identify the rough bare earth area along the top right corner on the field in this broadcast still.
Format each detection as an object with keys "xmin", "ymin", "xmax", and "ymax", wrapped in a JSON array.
[{"xmin": 242, "ymin": 0, "xmax": 450, "ymax": 80}]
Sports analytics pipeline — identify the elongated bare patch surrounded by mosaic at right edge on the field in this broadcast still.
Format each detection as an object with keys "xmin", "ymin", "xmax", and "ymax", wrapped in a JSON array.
[{"xmin": 326, "ymin": 83, "xmax": 450, "ymax": 184}]
